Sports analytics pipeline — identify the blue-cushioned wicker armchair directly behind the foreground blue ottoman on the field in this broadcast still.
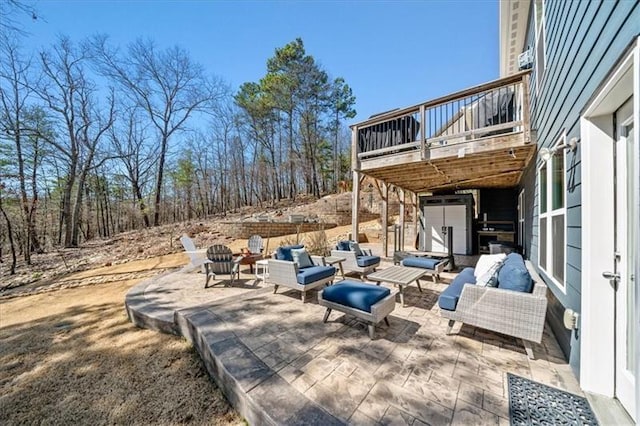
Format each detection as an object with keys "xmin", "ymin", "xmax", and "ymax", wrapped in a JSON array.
[{"xmin": 267, "ymin": 245, "xmax": 336, "ymax": 303}]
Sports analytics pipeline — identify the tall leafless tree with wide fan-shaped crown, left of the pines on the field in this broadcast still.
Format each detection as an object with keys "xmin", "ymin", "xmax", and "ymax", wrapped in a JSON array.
[{"xmin": 92, "ymin": 36, "xmax": 228, "ymax": 226}]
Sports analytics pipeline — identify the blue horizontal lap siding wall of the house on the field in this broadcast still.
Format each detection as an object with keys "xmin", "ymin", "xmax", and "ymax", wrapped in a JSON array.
[{"xmin": 522, "ymin": 0, "xmax": 640, "ymax": 375}]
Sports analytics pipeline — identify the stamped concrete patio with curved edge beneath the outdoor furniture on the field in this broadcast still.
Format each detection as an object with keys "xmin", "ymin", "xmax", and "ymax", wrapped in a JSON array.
[{"xmin": 126, "ymin": 255, "xmax": 583, "ymax": 426}]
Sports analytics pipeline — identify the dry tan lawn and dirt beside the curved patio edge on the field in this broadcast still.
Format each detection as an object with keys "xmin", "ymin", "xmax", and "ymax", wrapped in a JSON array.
[{"xmin": 0, "ymin": 218, "xmax": 382, "ymax": 425}]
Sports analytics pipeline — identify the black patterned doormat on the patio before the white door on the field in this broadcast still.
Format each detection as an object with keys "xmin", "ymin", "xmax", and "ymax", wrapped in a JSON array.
[{"xmin": 507, "ymin": 373, "xmax": 598, "ymax": 426}]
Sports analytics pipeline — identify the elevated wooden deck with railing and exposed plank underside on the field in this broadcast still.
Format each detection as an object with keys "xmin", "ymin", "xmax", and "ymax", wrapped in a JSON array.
[{"xmin": 351, "ymin": 72, "xmax": 536, "ymax": 193}]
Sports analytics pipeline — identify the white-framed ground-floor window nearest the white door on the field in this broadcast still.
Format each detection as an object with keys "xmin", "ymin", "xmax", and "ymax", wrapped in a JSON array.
[{"xmin": 538, "ymin": 135, "xmax": 566, "ymax": 288}]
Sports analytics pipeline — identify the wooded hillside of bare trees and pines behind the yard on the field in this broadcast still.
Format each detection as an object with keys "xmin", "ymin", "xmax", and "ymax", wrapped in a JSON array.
[{"xmin": 0, "ymin": 1, "xmax": 355, "ymax": 273}]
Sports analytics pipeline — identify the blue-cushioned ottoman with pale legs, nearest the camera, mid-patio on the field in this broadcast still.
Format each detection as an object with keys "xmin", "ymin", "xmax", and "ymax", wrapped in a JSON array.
[{"xmin": 318, "ymin": 280, "xmax": 396, "ymax": 339}]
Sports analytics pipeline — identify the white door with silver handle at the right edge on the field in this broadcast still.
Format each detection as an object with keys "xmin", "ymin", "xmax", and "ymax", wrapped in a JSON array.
[{"xmin": 614, "ymin": 101, "xmax": 640, "ymax": 420}]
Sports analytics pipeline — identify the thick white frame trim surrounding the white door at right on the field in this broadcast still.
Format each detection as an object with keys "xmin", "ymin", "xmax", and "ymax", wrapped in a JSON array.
[{"xmin": 580, "ymin": 42, "xmax": 640, "ymax": 398}]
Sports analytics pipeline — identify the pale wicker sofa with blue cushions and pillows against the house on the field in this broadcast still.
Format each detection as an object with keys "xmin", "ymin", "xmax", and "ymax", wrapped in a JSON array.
[{"xmin": 438, "ymin": 253, "xmax": 547, "ymax": 359}]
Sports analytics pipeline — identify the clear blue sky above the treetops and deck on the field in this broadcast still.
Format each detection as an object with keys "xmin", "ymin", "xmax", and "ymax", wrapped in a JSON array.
[{"xmin": 16, "ymin": 0, "xmax": 499, "ymax": 122}]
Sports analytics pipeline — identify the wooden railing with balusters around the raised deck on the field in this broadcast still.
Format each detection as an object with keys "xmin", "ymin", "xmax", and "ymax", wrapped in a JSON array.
[{"xmin": 352, "ymin": 72, "xmax": 529, "ymax": 160}]
